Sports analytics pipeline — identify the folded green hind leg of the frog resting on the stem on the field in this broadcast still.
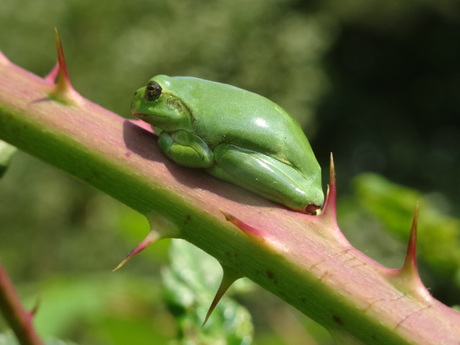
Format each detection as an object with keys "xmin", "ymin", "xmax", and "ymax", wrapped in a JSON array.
[{"xmin": 207, "ymin": 144, "xmax": 322, "ymax": 213}]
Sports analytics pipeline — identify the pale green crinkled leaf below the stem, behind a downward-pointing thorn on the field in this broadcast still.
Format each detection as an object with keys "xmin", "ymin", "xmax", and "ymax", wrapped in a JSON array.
[{"xmin": 163, "ymin": 240, "xmax": 253, "ymax": 345}]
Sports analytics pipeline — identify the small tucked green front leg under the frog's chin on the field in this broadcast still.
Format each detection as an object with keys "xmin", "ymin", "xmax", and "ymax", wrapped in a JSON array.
[{"xmin": 158, "ymin": 131, "xmax": 214, "ymax": 168}]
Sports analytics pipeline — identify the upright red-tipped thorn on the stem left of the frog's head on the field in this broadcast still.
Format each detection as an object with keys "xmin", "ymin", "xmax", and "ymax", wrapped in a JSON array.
[{"xmin": 45, "ymin": 28, "xmax": 81, "ymax": 105}]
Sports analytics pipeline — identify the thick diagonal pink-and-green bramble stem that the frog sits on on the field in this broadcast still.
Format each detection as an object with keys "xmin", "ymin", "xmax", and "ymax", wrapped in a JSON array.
[{"xmin": 0, "ymin": 52, "xmax": 460, "ymax": 345}]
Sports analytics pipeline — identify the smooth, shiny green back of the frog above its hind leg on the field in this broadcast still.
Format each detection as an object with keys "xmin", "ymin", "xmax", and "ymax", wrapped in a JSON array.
[{"xmin": 158, "ymin": 77, "xmax": 320, "ymax": 176}]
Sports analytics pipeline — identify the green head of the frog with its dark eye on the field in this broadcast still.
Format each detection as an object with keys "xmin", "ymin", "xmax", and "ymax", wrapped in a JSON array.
[{"xmin": 131, "ymin": 75, "xmax": 190, "ymax": 130}]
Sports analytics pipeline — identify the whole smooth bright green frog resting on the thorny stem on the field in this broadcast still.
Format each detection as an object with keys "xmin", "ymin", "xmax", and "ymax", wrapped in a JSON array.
[{"xmin": 131, "ymin": 75, "xmax": 324, "ymax": 213}]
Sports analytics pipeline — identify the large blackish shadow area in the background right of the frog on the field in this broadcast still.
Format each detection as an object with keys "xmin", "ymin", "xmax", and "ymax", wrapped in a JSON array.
[{"xmin": 312, "ymin": 9, "xmax": 460, "ymax": 208}]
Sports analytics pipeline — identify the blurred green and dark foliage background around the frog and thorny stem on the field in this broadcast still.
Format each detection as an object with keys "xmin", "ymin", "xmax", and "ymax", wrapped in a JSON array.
[{"xmin": 0, "ymin": 0, "xmax": 460, "ymax": 345}]
